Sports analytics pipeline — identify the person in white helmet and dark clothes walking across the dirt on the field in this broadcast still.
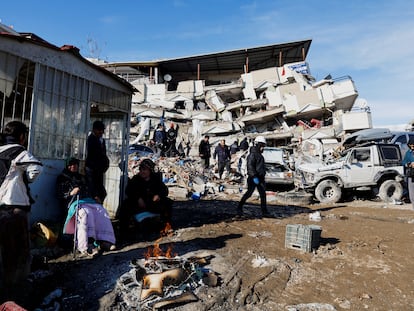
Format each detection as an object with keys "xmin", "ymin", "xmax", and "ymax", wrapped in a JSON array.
[{"xmin": 237, "ymin": 136, "xmax": 269, "ymax": 217}]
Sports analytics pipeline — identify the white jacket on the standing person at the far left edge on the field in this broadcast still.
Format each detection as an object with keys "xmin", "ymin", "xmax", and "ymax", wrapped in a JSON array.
[{"xmin": 0, "ymin": 144, "xmax": 42, "ymax": 207}]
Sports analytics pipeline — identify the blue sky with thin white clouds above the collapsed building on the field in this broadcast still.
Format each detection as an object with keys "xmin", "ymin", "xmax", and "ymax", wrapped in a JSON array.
[{"xmin": 0, "ymin": 0, "xmax": 414, "ymax": 128}]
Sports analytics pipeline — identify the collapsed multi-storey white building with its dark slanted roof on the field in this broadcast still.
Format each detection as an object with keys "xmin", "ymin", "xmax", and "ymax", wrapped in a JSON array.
[{"xmin": 100, "ymin": 40, "xmax": 372, "ymax": 155}]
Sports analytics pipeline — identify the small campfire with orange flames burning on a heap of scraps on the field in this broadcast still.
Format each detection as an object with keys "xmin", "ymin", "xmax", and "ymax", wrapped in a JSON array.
[{"xmin": 112, "ymin": 224, "xmax": 218, "ymax": 310}]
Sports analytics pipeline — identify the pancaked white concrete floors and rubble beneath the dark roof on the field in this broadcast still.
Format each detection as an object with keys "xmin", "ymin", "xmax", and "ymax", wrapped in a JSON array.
[{"xmin": 130, "ymin": 62, "xmax": 372, "ymax": 196}]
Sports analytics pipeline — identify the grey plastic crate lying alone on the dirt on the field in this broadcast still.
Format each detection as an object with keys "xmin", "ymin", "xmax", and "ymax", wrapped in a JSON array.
[{"xmin": 285, "ymin": 224, "xmax": 322, "ymax": 252}]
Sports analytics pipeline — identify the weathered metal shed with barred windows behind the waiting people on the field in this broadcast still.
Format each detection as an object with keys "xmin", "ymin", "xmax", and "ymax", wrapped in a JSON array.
[{"xmin": 0, "ymin": 25, "xmax": 133, "ymax": 222}]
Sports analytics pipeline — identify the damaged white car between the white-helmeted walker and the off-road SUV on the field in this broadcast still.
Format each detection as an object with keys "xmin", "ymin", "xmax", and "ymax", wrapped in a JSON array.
[{"xmin": 263, "ymin": 147, "xmax": 294, "ymax": 186}]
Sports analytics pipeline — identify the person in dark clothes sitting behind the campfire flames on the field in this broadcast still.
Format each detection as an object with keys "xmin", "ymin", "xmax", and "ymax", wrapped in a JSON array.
[{"xmin": 119, "ymin": 159, "xmax": 172, "ymax": 238}]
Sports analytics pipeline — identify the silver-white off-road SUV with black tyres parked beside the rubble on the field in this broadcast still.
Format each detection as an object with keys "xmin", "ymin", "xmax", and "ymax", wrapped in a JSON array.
[{"xmin": 295, "ymin": 143, "xmax": 403, "ymax": 203}]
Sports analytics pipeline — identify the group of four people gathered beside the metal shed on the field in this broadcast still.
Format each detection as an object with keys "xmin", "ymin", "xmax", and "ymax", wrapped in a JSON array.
[{"xmin": 0, "ymin": 121, "xmax": 172, "ymax": 300}]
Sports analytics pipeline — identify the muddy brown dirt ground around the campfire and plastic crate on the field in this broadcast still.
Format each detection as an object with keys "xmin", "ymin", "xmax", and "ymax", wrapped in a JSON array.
[{"xmin": 7, "ymin": 194, "xmax": 414, "ymax": 311}]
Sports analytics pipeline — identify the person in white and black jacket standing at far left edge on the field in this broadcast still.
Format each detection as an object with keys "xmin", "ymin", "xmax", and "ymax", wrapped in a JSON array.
[{"xmin": 0, "ymin": 121, "xmax": 42, "ymax": 301}]
